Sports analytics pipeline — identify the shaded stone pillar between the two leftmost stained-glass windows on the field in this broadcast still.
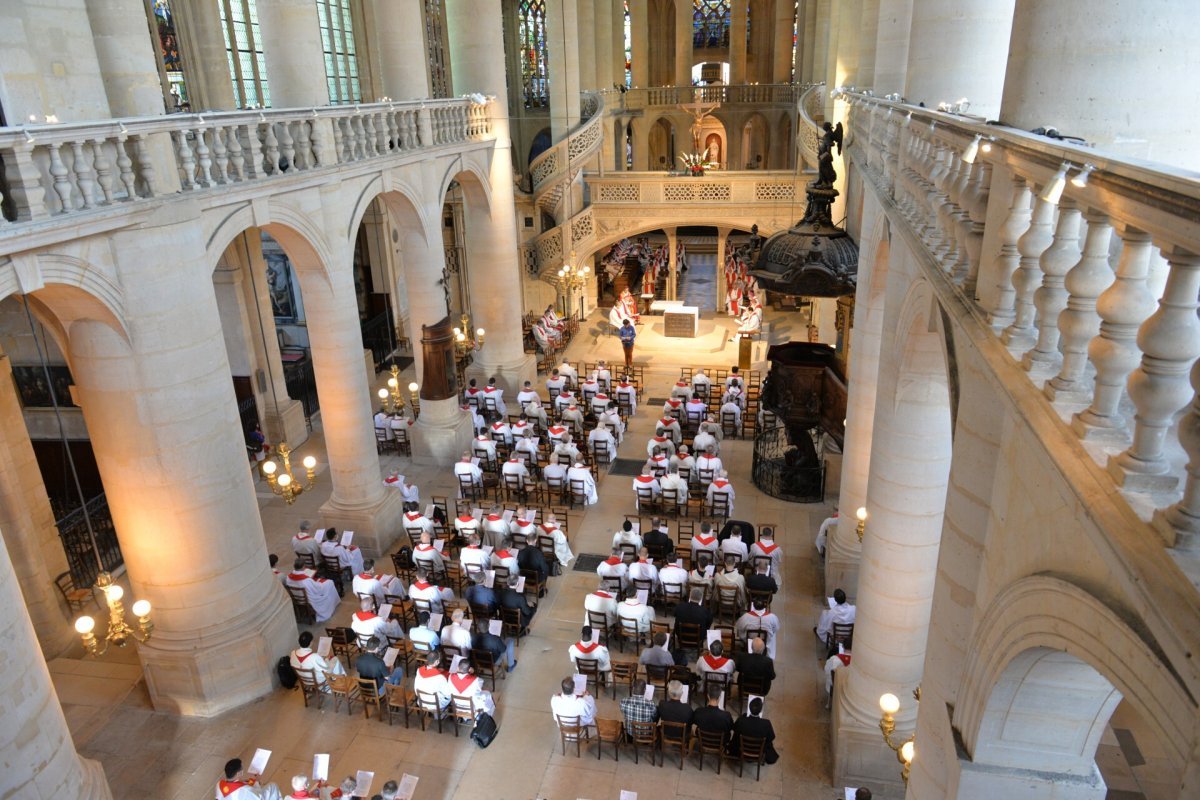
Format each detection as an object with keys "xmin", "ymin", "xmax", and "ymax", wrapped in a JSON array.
[{"xmin": 170, "ymin": 0, "xmax": 236, "ymax": 112}]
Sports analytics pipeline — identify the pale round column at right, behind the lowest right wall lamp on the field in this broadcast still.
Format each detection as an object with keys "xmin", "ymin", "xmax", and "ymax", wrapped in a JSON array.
[{"xmin": 828, "ymin": 311, "xmax": 952, "ymax": 786}]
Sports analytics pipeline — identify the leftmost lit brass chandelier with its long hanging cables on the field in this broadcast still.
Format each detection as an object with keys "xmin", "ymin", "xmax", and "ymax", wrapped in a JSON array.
[{"xmin": 24, "ymin": 300, "xmax": 154, "ymax": 656}]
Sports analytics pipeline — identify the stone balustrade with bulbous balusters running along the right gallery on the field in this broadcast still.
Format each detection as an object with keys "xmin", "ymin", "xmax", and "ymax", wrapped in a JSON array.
[{"xmin": 848, "ymin": 94, "xmax": 1200, "ymax": 552}]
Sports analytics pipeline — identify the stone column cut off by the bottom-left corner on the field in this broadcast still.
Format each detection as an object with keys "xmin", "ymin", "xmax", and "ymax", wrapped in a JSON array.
[{"xmin": 0, "ymin": 529, "xmax": 113, "ymax": 800}]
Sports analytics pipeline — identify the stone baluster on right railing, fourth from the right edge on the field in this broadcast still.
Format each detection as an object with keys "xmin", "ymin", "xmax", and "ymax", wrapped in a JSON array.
[{"xmin": 1045, "ymin": 210, "xmax": 1114, "ymax": 403}]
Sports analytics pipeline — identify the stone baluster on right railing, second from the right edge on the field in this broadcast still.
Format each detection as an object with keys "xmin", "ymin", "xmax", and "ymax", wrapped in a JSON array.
[{"xmin": 1108, "ymin": 251, "xmax": 1200, "ymax": 492}]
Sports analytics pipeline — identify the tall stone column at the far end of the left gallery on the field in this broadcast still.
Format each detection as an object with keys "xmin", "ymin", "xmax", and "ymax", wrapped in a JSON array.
[{"xmin": 446, "ymin": 0, "xmax": 537, "ymax": 397}]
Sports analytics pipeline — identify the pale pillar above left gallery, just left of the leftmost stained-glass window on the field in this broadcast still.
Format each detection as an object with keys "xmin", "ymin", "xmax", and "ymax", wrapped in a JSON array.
[{"xmin": 88, "ymin": 0, "xmax": 166, "ymax": 116}]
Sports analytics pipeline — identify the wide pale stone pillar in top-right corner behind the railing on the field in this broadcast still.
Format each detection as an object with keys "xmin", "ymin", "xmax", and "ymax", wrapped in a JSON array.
[{"xmin": 1003, "ymin": 0, "xmax": 1200, "ymax": 170}]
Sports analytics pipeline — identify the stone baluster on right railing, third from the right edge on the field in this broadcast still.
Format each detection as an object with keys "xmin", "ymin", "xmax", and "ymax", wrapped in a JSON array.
[{"xmin": 1070, "ymin": 225, "xmax": 1154, "ymax": 441}]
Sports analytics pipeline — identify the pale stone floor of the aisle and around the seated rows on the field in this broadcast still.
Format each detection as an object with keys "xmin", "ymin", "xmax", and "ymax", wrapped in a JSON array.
[{"xmin": 50, "ymin": 309, "xmax": 1159, "ymax": 800}]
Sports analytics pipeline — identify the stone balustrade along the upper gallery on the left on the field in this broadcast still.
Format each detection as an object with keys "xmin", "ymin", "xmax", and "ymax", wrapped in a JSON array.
[{"xmin": 0, "ymin": 98, "xmax": 491, "ymax": 228}]
